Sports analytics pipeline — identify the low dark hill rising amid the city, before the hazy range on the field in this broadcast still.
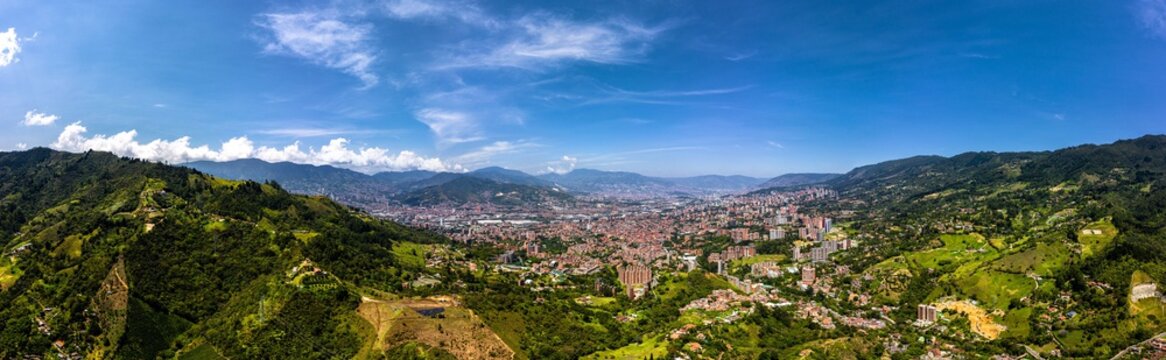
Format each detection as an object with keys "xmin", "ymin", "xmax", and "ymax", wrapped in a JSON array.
[{"xmin": 398, "ymin": 175, "xmax": 574, "ymax": 206}]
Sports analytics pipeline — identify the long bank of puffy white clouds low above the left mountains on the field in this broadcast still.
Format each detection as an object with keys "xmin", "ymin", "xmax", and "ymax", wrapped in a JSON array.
[{"xmin": 51, "ymin": 122, "xmax": 465, "ymax": 172}]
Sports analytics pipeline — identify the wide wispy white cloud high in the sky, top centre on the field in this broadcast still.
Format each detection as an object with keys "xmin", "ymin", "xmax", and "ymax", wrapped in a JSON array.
[{"xmin": 438, "ymin": 13, "xmax": 663, "ymax": 70}]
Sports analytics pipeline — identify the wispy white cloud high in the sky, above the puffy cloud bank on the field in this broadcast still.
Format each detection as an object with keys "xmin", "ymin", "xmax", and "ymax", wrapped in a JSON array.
[{"xmin": 257, "ymin": 12, "xmax": 380, "ymax": 87}]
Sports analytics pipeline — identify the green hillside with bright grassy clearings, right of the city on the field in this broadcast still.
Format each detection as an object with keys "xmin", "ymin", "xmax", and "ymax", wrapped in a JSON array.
[{"xmin": 807, "ymin": 135, "xmax": 1166, "ymax": 358}]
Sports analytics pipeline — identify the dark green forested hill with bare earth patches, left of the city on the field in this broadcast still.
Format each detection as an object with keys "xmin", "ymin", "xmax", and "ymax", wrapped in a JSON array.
[{"xmin": 0, "ymin": 148, "xmax": 438, "ymax": 359}]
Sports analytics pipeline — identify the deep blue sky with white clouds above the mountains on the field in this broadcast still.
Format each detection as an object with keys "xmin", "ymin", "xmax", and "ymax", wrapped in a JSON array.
[{"xmin": 0, "ymin": 0, "xmax": 1166, "ymax": 177}]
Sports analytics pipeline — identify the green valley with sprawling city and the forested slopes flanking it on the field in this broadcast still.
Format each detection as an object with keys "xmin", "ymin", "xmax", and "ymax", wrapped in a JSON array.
[{"xmin": 0, "ymin": 136, "xmax": 1166, "ymax": 359}]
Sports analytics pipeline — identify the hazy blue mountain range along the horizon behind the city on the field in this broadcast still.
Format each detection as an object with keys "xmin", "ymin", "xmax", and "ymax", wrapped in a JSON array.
[{"xmin": 184, "ymin": 158, "xmax": 831, "ymax": 206}]
